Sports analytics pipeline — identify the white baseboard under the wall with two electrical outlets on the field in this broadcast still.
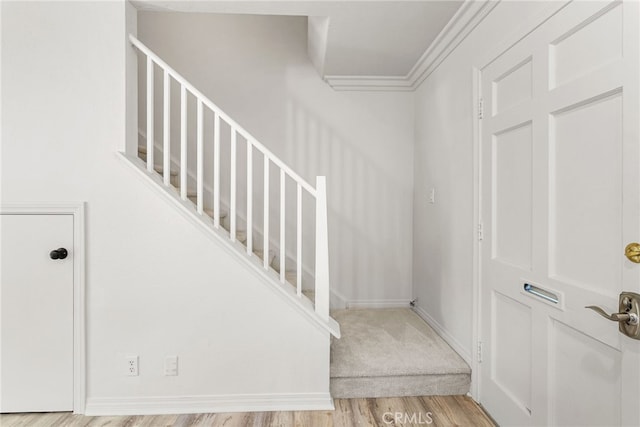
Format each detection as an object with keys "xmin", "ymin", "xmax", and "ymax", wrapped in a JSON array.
[{"xmin": 84, "ymin": 393, "xmax": 335, "ymax": 416}]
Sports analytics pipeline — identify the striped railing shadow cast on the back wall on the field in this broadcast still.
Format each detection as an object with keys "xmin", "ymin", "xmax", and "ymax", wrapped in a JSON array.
[{"xmin": 286, "ymin": 96, "xmax": 411, "ymax": 301}]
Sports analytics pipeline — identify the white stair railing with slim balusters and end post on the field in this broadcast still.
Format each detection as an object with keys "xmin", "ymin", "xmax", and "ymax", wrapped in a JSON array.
[{"xmin": 129, "ymin": 35, "xmax": 329, "ymax": 320}]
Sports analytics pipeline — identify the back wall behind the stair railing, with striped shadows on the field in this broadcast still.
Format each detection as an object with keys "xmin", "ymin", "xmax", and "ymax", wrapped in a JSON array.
[{"xmin": 138, "ymin": 11, "xmax": 413, "ymax": 303}]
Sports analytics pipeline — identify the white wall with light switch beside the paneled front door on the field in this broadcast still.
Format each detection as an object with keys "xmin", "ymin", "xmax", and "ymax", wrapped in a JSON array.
[{"xmin": 413, "ymin": 1, "xmax": 549, "ymax": 360}]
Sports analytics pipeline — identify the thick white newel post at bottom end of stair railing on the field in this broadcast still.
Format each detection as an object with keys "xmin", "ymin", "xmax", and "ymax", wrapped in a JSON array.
[{"xmin": 315, "ymin": 176, "xmax": 329, "ymax": 320}]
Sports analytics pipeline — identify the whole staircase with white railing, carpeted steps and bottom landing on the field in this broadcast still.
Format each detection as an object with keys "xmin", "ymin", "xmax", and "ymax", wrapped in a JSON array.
[{"xmin": 124, "ymin": 36, "xmax": 470, "ymax": 398}]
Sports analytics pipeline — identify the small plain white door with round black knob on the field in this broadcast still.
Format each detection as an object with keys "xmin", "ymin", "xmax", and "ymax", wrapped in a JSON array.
[{"xmin": 0, "ymin": 214, "xmax": 74, "ymax": 412}]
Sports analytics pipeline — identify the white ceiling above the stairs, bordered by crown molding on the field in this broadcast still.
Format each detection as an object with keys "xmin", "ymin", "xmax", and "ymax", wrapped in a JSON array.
[{"xmin": 132, "ymin": 0, "xmax": 464, "ymax": 77}]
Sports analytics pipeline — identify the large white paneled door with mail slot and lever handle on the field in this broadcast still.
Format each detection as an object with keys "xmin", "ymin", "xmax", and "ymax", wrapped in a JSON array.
[{"xmin": 479, "ymin": 1, "xmax": 640, "ymax": 426}]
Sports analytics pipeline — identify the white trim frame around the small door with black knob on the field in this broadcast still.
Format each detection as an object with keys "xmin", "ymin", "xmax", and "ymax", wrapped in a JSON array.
[{"xmin": 0, "ymin": 202, "xmax": 86, "ymax": 414}]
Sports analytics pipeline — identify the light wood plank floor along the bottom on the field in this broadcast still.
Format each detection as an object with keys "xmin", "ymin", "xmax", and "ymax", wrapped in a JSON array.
[{"xmin": 0, "ymin": 396, "xmax": 495, "ymax": 427}]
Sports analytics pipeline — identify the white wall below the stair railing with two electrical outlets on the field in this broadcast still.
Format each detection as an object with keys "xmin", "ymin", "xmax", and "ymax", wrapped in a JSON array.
[{"xmin": 0, "ymin": 1, "xmax": 336, "ymax": 412}]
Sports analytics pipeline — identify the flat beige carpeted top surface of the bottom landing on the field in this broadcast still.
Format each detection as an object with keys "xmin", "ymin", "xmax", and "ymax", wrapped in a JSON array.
[{"xmin": 331, "ymin": 308, "xmax": 471, "ymax": 378}]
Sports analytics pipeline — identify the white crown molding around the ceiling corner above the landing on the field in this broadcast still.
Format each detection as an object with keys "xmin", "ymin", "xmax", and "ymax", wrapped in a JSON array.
[{"xmin": 324, "ymin": 0, "xmax": 500, "ymax": 91}]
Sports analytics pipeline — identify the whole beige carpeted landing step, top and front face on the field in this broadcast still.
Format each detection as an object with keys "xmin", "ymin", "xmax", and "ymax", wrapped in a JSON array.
[{"xmin": 331, "ymin": 308, "xmax": 471, "ymax": 398}]
